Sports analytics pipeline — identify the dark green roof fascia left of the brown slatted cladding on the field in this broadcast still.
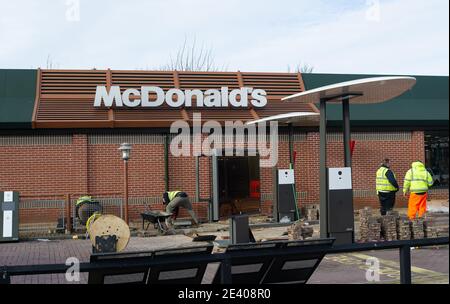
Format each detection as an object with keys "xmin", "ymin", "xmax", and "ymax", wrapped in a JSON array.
[{"xmin": 0, "ymin": 69, "xmax": 37, "ymax": 129}]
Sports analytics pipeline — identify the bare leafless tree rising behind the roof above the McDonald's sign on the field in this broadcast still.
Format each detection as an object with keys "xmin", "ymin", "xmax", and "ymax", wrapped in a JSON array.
[{"xmin": 159, "ymin": 38, "xmax": 226, "ymax": 71}]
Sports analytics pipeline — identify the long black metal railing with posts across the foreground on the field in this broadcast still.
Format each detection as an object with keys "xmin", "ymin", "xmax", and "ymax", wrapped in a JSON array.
[{"xmin": 0, "ymin": 237, "xmax": 449, "ymax": 284}]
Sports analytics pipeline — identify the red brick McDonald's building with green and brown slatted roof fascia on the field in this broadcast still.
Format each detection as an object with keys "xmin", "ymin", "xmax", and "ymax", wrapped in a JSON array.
[{"xmin": 0, "ymin": 70, "xmax": 449, "ymax": 230}]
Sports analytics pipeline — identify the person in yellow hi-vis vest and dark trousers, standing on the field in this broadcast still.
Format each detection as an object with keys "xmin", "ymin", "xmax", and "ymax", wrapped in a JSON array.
[{"xmin": 376, "ymin": 158, "xmax": 399, "ymax": 215}]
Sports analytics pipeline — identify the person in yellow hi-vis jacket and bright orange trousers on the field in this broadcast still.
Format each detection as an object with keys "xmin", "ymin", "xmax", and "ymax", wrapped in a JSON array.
[{"xmin": 403, "ymin": 160, "xmax": 433, "ymax": 220}]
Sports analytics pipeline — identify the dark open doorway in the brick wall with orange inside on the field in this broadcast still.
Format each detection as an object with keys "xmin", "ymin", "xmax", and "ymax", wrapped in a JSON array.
[{"xmin": 217, "ymin": 156, "xmax": 261, "ymax": 217}]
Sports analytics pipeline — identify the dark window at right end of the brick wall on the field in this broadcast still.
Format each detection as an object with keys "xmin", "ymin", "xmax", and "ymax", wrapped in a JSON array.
[{"xmin": 425, "ymin": 131, "xmax": 449, "ymax": 188}]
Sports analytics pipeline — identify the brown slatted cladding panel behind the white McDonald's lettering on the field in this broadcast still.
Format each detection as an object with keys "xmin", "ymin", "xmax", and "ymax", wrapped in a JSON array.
[{"xmin": 33, "ymin": 70, "xmax": 314, "ymax": 128}]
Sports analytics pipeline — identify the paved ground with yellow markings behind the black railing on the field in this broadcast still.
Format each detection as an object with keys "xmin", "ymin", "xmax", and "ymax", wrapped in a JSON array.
[{"xmin": 0, "ymin": 211, "xmax": 449, "ymax": 284}]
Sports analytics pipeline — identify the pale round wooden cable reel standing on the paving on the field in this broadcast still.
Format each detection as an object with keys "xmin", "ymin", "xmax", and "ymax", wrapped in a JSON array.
[{"xmin": 88, "ymin": 214, "xmax": 130, "ymax": 252}]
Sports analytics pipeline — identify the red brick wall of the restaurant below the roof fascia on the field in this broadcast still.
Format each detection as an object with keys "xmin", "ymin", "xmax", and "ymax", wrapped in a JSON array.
[{"xmin": 0, "ymin": 131, "xmax": 448, "ymax": 224}]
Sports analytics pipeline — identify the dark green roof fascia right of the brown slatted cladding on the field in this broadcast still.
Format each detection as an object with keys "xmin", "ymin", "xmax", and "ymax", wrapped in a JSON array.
[{"xmin": 302, "ymin": 74, "xmax": 449, "ymax": 128}]
